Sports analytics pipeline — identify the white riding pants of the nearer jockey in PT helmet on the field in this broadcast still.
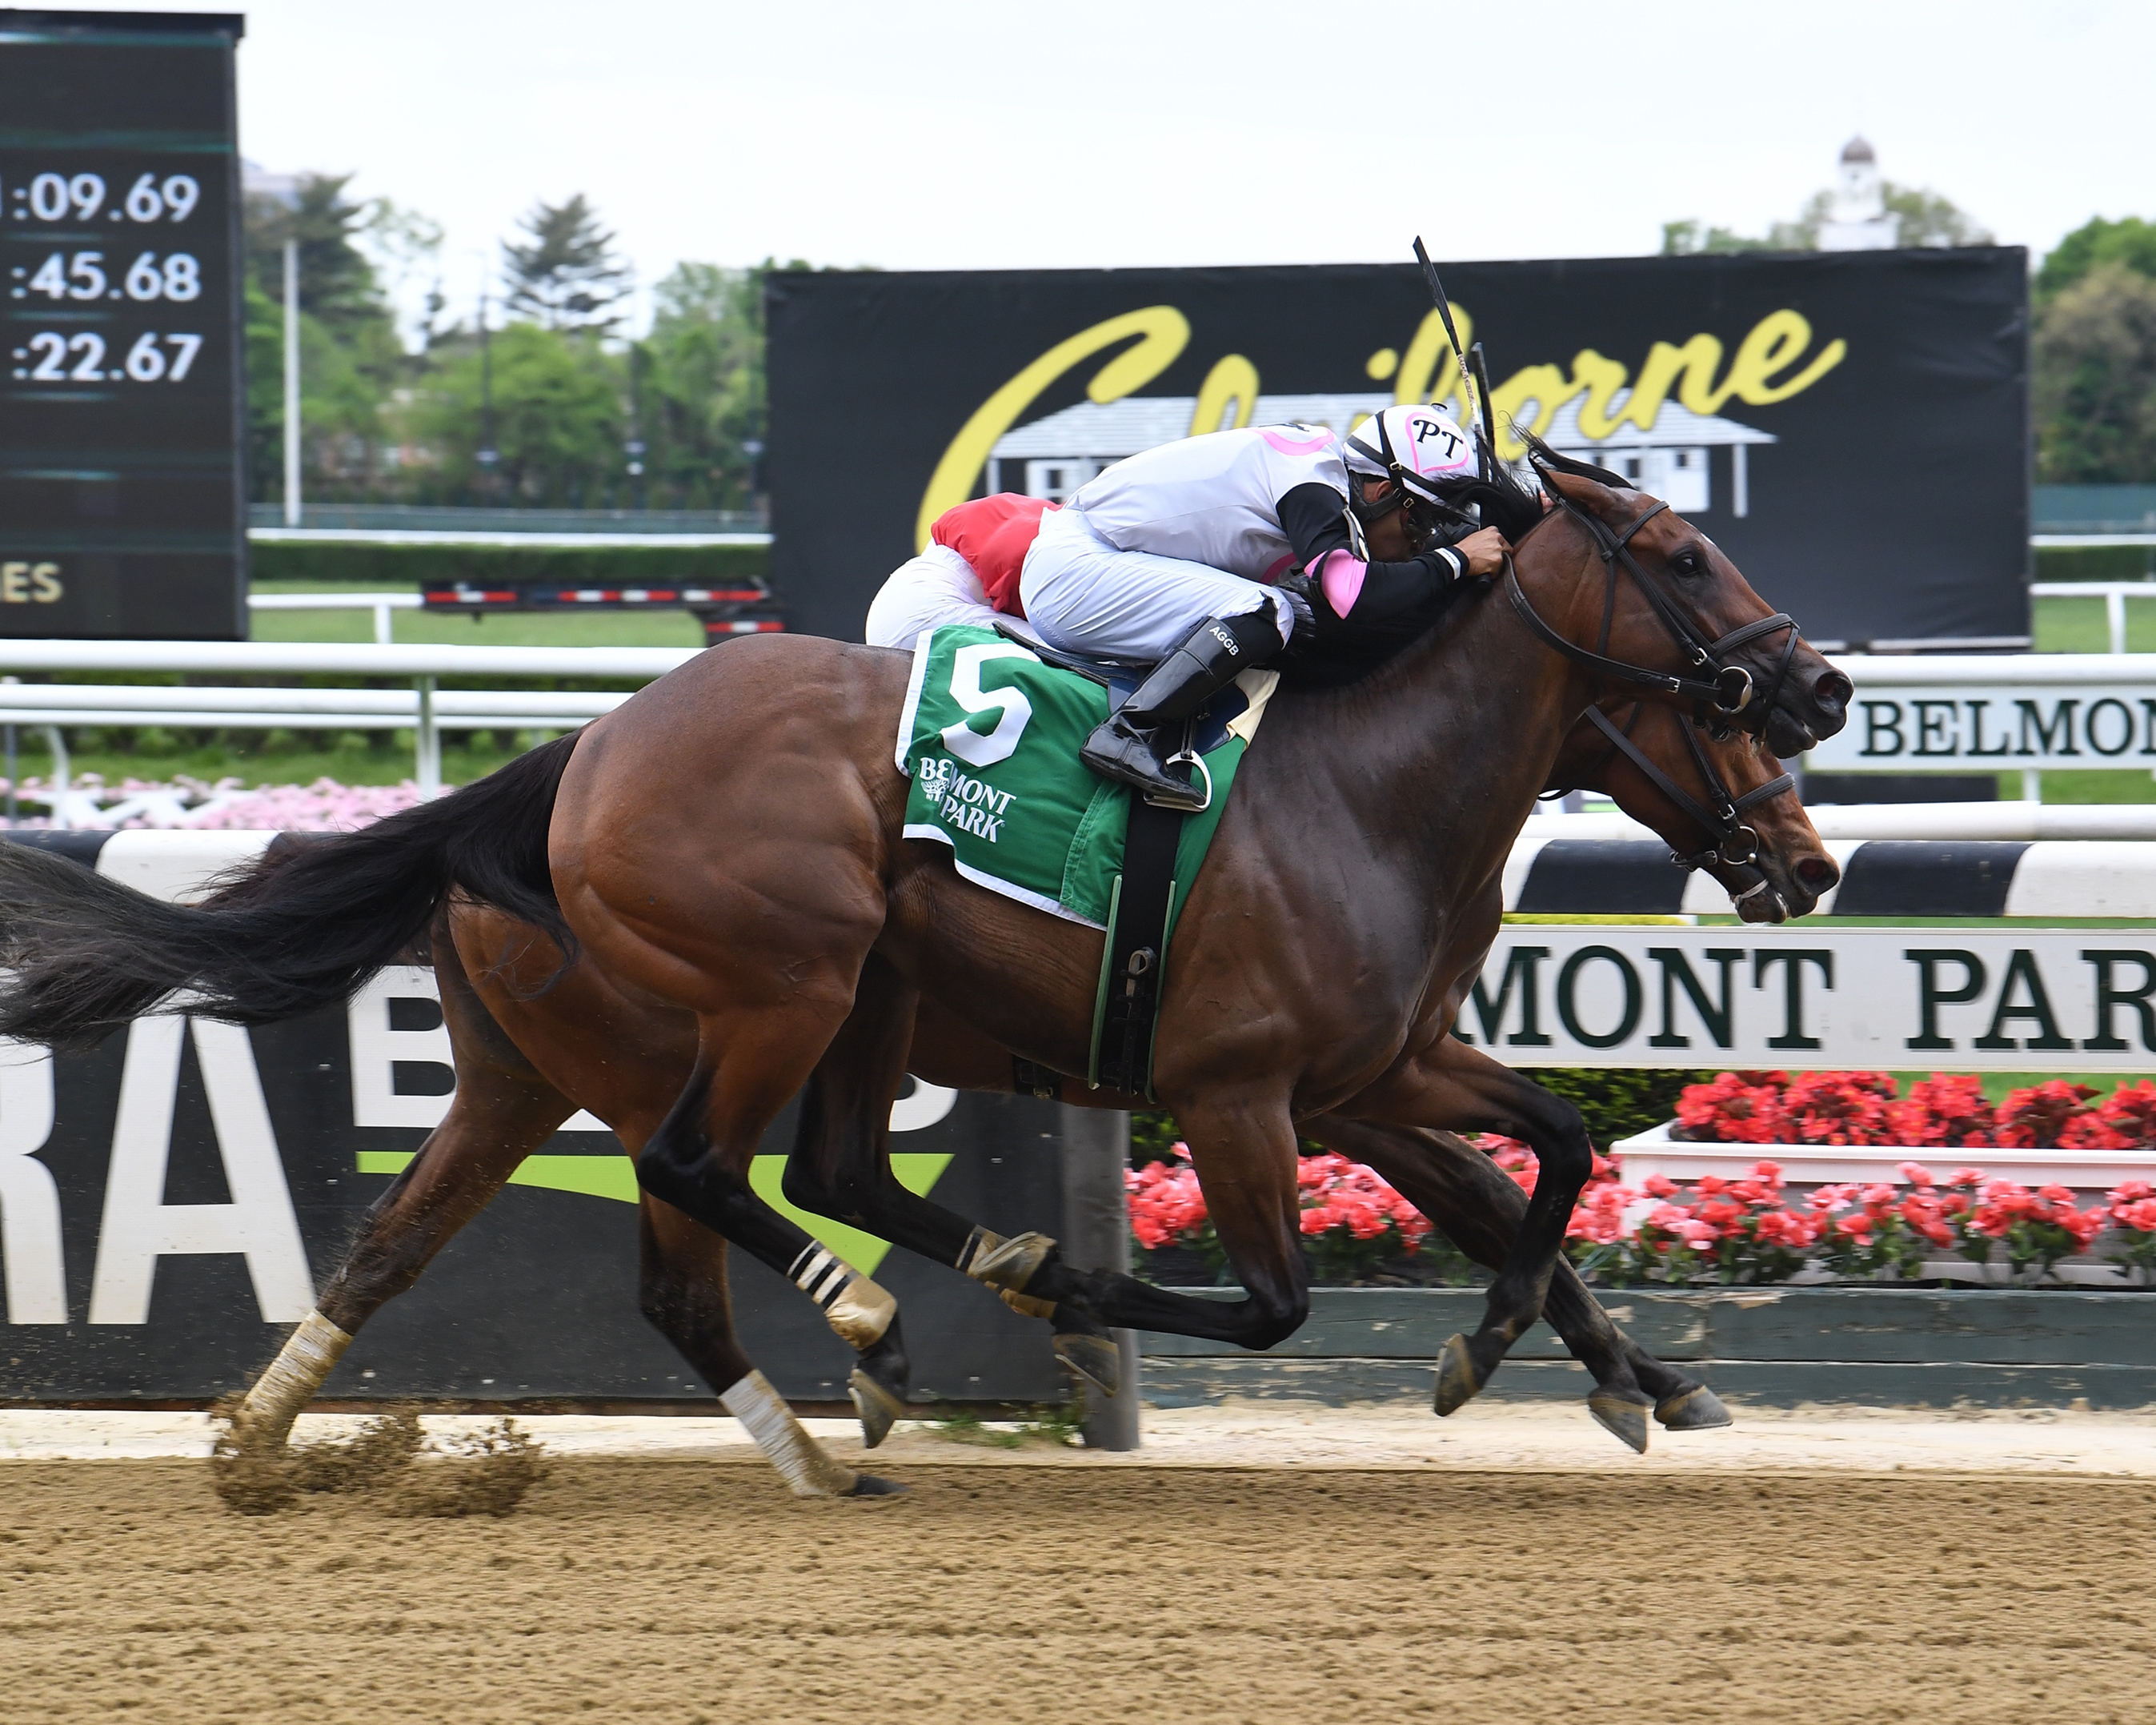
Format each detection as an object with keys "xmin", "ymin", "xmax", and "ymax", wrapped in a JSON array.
[{"xmin": 1018, "ymin": 504, "xmax": 1296, "ymax": 662}]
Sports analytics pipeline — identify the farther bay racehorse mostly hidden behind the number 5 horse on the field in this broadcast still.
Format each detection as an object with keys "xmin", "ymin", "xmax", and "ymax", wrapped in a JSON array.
[{"xmin": 248, "ymin": 676, "xmax": 1837, "ymax": 1492}]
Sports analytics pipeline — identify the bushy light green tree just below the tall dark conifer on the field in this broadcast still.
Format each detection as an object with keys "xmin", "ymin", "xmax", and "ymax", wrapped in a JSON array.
[{"xmin": 410, "ymin": 323, "xmax": 625, "ymax": 509}]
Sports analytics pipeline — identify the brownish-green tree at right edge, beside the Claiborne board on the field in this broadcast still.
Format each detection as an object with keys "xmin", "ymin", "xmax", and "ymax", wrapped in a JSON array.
[{"xmin": 2033, "ymin": 266, "xmax": 2156, "ymax": 485}]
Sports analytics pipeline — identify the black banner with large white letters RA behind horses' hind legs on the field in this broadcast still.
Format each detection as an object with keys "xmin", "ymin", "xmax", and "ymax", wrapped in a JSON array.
[{"xmin": 0, "ymin": 968, "xmax": 1065, "ymax": 1402}]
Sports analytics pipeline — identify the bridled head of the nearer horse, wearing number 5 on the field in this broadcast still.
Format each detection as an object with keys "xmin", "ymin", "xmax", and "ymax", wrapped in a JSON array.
[{"xmin": 1511, "ymin": 442, "xmax": 1852, "ymax": 755}]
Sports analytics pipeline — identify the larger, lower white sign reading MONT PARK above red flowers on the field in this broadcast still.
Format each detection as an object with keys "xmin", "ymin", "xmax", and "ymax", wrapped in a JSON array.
[{"xmin": 1453, "ymin": 923, "xmax": 2156, "ymax": 1072}]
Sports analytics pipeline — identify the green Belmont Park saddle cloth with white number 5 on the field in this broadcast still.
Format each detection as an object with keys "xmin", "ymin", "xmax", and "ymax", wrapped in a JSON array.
[{"xmin": 895, "ymin": 625, "xmax": 1279, "ymax": 1097}]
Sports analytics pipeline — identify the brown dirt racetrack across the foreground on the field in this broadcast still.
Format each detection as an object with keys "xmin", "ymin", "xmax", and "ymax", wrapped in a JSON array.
[{"xmin": 0, "ymin": 1458, "xmax": 2156, "ymax": 1725}]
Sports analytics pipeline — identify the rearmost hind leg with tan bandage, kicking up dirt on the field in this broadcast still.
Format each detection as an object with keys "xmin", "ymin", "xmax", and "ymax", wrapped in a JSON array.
[{"xmin": 235, "ymin": 925, "xmax": 574, "ymax": 1445}]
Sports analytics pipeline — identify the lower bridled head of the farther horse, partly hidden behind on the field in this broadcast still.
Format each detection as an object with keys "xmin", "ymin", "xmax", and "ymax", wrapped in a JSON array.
[{"xmin": 1550, "ymin": 700, "xmax": 1841, "ymax": 923}]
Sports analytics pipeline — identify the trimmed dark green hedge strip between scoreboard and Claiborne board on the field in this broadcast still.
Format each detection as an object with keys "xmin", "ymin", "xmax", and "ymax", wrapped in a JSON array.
[{"xmin": 248, "ymin": 541, "xmax": 771, "ymax": 591}]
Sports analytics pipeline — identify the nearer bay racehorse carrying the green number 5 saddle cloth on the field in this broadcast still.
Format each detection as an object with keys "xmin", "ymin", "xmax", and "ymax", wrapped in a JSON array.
[{"xmin": 0, "ymin": 450, "xmax": 1848, "ymax": 1492}]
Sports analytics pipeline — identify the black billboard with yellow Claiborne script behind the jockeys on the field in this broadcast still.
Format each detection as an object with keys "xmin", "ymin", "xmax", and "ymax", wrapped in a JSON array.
[{"xmin": 767, "ymin": 248, "xmax": 2029, "ymax": 647}]
